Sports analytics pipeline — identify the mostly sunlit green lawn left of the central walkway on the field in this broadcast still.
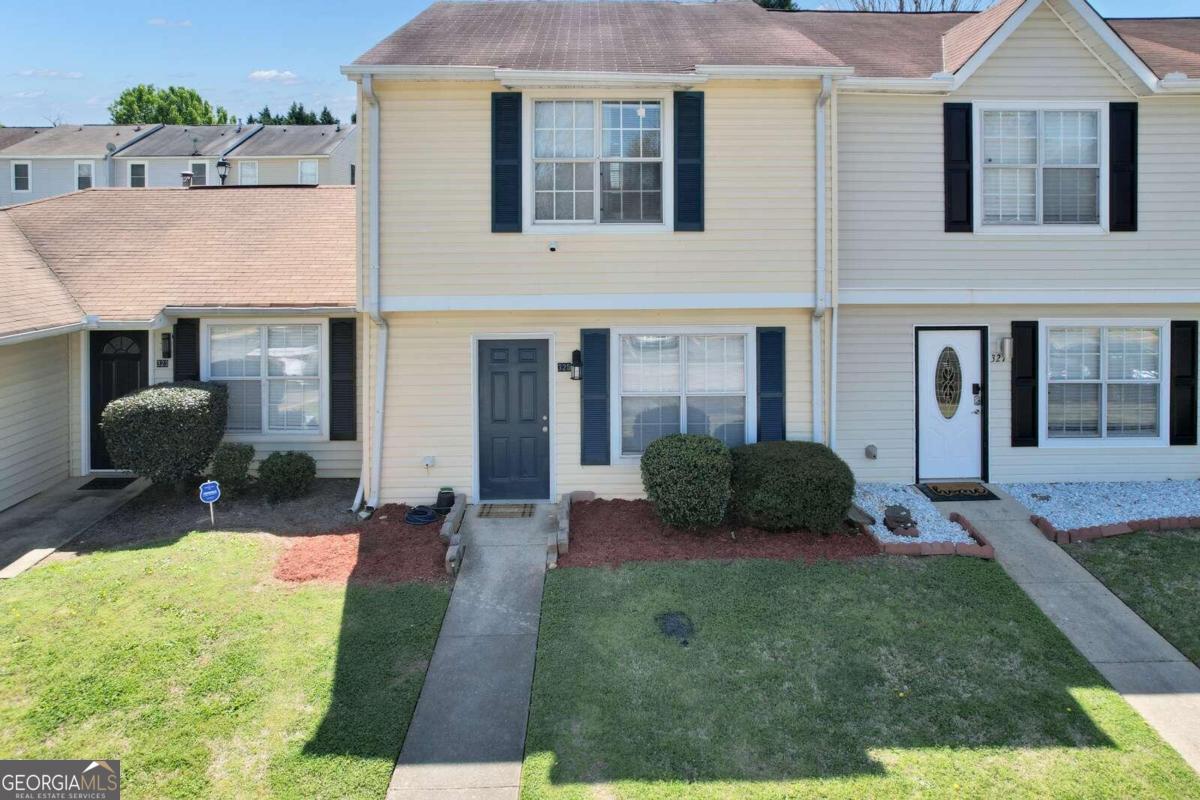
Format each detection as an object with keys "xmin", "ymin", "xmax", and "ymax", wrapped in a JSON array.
[{"xmin": 0, "ymin": 533, "xmax": 448, "ymax": 800}]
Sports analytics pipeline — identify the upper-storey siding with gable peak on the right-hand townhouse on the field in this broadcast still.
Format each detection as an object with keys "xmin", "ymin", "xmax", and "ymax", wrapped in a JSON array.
[{"xmin": 838, "ymin": 7, "xmax": 1200, "ymax": 291}]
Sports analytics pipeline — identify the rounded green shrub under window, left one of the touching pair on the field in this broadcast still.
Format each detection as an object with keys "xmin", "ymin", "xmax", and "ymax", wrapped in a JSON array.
[{"xmin": 642, "ymin": 433, "xmax": 732, "ymax": 528}]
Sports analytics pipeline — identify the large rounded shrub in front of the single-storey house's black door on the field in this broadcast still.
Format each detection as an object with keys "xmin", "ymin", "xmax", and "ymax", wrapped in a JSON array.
[{"xmin": 100, "ymin": 381, "xmax": 229, "ymax": 483}]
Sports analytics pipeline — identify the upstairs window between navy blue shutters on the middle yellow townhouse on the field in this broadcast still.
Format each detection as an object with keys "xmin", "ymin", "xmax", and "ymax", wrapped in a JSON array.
[{"xmin": 533, "ymin": 100, "xmax": 662, "ymax": 224}]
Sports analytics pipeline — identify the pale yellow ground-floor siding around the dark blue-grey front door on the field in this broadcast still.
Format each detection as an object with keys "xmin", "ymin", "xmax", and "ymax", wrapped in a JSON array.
[{"xmin": 367, "ymin": 309, "xmax": 812, "ymax": 503}]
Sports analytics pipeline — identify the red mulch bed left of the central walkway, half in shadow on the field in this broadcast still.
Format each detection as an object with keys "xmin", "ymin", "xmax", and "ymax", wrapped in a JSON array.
[{"xmin": 275, "ymin": 505, "xmax": 446, "ymax": 583}]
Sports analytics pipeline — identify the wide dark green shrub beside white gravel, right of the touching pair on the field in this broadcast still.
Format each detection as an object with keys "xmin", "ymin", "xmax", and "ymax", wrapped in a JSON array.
[{"xmin": 732, "ymin": 441, "xmax": 854, "ymax": 534}]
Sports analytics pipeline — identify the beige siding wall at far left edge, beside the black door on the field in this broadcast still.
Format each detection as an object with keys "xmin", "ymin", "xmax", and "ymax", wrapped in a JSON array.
[{"xmin": 0, "ymin": 336, "xmax": 70, "ymax": 509}]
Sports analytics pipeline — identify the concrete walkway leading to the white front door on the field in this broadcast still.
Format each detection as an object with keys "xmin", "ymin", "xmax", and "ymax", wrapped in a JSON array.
[{"xmin": 937, "ymin": 487, "xmax": 1200, "ymax": 772}]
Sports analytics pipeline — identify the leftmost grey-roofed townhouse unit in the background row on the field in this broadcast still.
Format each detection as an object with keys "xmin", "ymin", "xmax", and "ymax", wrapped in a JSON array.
[{"xmin": 0, "ymin": 125, "xmax": 162, "ymax": 206}]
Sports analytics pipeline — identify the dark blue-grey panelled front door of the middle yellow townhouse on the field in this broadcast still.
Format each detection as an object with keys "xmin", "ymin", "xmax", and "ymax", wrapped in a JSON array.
[{"xmin": 479, "ymin": 339, "xmax": 550, "ymax": 500}]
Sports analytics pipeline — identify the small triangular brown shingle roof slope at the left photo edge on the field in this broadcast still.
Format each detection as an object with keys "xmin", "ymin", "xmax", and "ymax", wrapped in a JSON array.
[{"xmin": 0, "ymin": 212, "xmax": 83, "ymax": 336}]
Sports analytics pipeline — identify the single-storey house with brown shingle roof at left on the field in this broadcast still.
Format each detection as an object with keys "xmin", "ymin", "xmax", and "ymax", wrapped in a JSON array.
[{"xmin": 0, "ymin": 187, "xmax": 361, "ymax": 509}]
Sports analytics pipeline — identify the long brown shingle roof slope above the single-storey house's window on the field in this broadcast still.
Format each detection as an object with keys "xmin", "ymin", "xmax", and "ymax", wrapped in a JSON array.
[{"xmin": 0, "ymin": 186, "xmax": 356, "ymax": 327}]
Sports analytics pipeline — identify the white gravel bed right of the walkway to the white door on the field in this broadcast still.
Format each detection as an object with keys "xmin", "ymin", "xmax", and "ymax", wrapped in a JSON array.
[{"xmin": 1000, "ymin": 481, "xmax": 1200, "ymax": 530}]
